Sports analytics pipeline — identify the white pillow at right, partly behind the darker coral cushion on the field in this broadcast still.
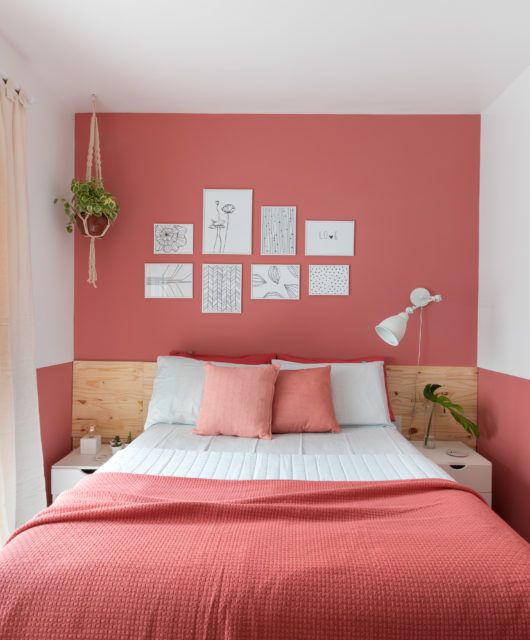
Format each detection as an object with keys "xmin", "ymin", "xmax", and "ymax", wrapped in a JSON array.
[{"xmin": 272, "ymin": 360, "xmax": 390, "ymax": 425}]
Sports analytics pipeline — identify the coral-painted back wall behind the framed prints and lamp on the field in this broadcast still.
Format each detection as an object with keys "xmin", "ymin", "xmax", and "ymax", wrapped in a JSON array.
[{"xmin": 75, "ymin": 114, "xmax": 480, "ymax": 365}]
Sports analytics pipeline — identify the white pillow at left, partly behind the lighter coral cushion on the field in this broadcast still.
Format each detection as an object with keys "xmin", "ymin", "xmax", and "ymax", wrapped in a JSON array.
[{"xmin": 144, "ymin": 356, "xmax": 260, "ymax": 429}]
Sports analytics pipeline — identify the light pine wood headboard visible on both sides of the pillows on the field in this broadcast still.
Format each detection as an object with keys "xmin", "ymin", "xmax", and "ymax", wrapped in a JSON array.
[{"xmin": 72, "ymin": 360, "xmax": 477, "ymax": 447}]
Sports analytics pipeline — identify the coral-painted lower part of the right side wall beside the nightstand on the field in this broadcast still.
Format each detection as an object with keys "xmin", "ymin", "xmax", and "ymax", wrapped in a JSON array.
[{"xmin": 478, "ymin": 369, "xmax": 530, "ymax": 542}]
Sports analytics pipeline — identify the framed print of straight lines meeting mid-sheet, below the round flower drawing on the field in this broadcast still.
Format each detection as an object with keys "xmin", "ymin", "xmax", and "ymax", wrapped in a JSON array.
[{"xmin": 144, "ymin": 262, "xmax": 193, "ymax": 299}]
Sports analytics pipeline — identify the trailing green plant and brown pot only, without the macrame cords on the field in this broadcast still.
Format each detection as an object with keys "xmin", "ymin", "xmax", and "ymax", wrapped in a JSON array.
[{"xmin": 54, "ymin": 178, "xmax": 120, "ymax": 238}]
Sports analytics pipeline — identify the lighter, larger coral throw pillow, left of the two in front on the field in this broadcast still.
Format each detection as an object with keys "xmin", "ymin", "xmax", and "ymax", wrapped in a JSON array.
[{"xmin": 193, "ymin": 364, "xmax": 279, "ymax": 440}]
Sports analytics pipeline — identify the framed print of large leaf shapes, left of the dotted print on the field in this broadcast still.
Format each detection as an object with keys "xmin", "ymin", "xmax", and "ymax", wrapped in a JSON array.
[{"xmin": 250, "ymin": 264, "xmax": 300, "ymax": 300}]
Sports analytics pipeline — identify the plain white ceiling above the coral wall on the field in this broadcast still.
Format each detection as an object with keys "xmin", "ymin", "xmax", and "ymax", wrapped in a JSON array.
[{"xmin": 0, "ymin": 0, "xmax": 530, "ymax": 113}]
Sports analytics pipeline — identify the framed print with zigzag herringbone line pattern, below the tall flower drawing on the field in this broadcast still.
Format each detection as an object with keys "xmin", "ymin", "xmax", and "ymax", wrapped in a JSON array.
[{"xmin": 202, "ymin": 264, "xmax": 243, "ymax": 313}]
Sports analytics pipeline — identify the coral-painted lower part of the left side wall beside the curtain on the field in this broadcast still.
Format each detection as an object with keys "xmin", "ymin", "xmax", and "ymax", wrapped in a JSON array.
[{"xmin": 37, "ymin": 362, "xmax": 72, "ymax": 503}]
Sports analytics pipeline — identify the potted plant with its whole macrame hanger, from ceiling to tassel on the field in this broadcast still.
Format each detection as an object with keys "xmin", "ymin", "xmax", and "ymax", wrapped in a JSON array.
[{"xmin": 54, "ymin": 96, "xmax": 120, "ymax": 287}]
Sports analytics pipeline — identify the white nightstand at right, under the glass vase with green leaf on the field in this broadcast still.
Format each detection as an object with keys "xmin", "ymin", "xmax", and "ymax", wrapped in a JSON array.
[{"xmin": 411, "ymin": 440, "xmax": 491, "ymax": 507}]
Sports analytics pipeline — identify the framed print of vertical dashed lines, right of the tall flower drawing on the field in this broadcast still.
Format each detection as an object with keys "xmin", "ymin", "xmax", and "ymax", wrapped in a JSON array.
[{"xmin": 261, "ymin": 206, "xmax": 296, "ymax": 256}]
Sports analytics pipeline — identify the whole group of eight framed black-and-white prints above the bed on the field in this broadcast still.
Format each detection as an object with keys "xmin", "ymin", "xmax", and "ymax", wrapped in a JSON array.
[{"xmin": 144, "ymin": 189, "xmax": 355, "ymax": 313}]
